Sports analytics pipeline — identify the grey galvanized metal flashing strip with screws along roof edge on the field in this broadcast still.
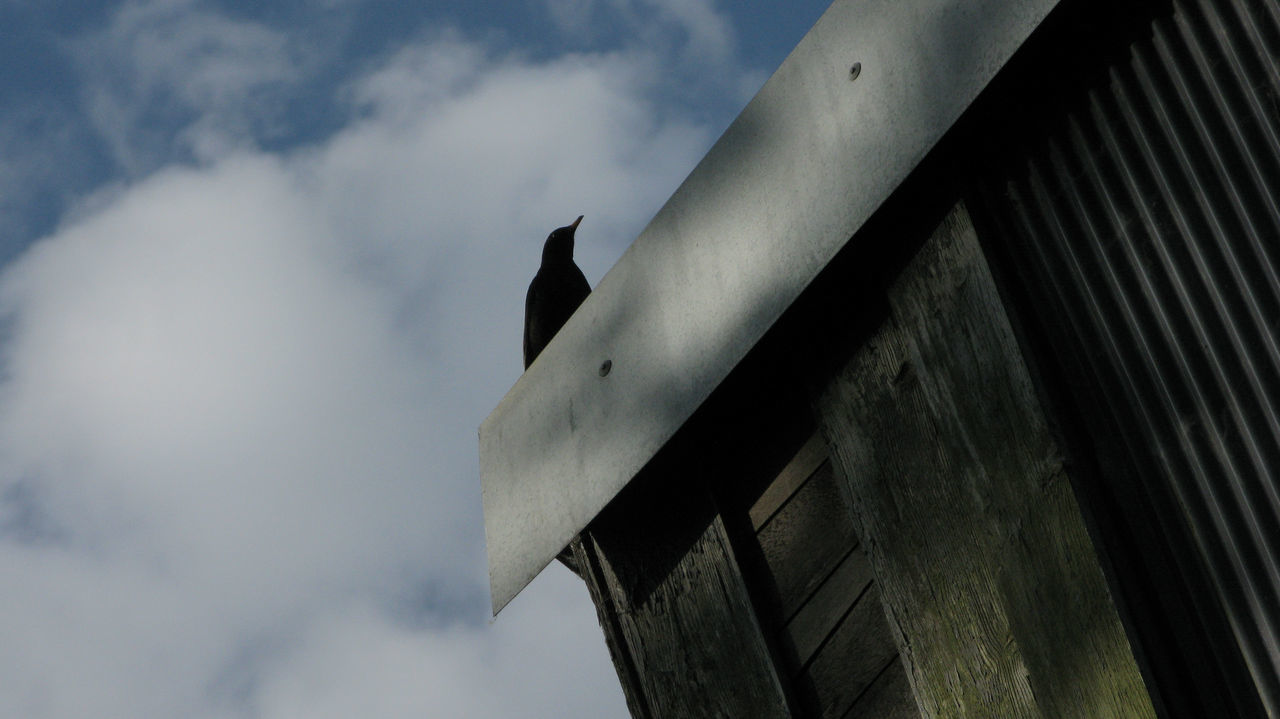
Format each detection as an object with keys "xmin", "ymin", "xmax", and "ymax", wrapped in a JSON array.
[{"xmin": 480, "ymin": 0, "xmax": 1057, "ymax": 614}]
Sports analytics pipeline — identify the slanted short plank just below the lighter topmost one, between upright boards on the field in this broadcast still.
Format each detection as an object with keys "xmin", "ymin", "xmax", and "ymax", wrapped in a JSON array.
[{"xmin": 756, "ymin": 462, "xmax": 858, "ymax": 620}]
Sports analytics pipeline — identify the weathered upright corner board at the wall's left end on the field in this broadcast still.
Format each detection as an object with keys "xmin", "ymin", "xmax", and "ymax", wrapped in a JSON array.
[{"xmin": 580, "ymin": 475, "xmax": 791, "ymax": 719}]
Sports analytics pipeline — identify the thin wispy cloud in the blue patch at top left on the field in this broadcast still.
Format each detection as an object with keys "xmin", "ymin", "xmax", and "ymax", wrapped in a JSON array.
[{"xmin": 68, "ymin": 0, "xmax": 310, "ymax": 170}]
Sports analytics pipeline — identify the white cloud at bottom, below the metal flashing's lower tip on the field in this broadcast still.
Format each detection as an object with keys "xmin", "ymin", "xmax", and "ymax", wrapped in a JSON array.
[{"xmin": 259, "ymin": 568, "xmax": 626, "ymax": 719}]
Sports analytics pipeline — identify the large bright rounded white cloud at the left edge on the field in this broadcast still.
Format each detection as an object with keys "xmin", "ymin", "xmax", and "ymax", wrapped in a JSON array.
[{"xmin": 0, "ymin": 152, "xmax": 451, "ymax": 582}]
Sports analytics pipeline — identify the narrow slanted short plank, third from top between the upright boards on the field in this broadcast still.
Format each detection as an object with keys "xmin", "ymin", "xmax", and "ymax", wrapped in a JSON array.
[{"xmin": 781, "ymin": 548, "xmax": 878, "ymax": 667}]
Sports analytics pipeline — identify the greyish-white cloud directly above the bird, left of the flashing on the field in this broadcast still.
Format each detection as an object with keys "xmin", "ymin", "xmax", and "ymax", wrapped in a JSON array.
[{"xmin": 307, "ymin": 40, "xmax": 710, "ymax": 301}]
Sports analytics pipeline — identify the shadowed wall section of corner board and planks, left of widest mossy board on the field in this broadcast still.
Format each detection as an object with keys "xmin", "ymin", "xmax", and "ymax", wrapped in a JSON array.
[{"xmin": 575, "ymin": 406, "xmax": 919, "ymax": 719}]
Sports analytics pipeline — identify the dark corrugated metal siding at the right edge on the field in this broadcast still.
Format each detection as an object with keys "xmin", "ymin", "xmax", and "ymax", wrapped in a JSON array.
[{"xmin": 986, "ymin": 0, "xmax": 1280, "ymax": 716}]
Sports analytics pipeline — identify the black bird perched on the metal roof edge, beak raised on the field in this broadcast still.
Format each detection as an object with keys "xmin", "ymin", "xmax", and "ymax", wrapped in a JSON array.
[{"xmin": 525, "ymin": 215, "xmax": 591, "ymax": 370}]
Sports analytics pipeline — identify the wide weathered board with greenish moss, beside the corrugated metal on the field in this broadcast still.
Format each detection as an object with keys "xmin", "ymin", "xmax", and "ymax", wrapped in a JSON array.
[{"xmin": 817, "ymin": 199, "xmax": 1153, "ymax": 719}]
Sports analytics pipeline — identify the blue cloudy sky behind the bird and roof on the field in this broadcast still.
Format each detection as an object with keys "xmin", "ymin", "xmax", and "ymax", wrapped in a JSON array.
[{"xmin": 0, "ymin": 0, "xmax": 826, "ymax": 719}]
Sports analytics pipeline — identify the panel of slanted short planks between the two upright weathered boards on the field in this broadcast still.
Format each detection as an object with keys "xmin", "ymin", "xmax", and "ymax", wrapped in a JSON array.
[{"xmin": 740, "ymin": 434, "xmax": 919, "ymax": 719}]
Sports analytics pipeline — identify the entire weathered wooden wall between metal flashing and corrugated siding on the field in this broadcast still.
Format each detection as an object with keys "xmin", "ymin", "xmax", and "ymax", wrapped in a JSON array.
[{"xmin": 575, "ymin": 193, "xmax": 1155, "ymax": 719}]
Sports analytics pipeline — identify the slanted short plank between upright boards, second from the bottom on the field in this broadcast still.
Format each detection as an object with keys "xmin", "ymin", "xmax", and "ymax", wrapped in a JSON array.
[{"xmin": 795, "ymin": 591, "xmax": 897, "ymax": 719}]
